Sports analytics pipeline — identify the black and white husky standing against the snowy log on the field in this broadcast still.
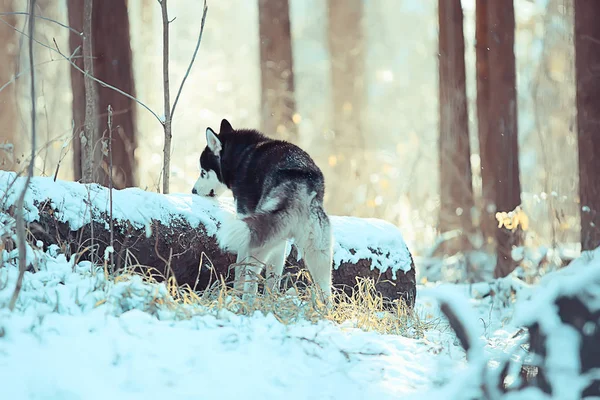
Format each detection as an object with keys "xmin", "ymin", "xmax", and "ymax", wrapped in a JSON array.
[{"xmin": 192, "ymin": 119, "xmax": 332, "ymax": 299}]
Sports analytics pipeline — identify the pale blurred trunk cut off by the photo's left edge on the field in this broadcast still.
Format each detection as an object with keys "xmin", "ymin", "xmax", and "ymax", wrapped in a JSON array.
[{"xmin": 0, "ymin": 0, "xmax": 18, "ymax": 170}]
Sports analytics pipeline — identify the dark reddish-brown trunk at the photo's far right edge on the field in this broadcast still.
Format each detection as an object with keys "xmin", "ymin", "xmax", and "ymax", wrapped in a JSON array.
[{"xmin": 575, "ymin": 0, "xmax": 600, "ymax": 250}]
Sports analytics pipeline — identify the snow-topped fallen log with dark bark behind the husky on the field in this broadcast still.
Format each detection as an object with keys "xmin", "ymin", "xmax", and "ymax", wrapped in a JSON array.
[{"xmin": 0, "ymin": 171, "xmax": 416, "ymax": 306}]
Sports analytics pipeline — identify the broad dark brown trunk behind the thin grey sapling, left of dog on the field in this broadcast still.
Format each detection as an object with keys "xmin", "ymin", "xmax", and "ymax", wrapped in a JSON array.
[{"xmin": 68, "ymin": 0, "xmax": 137, "ymax": 188}]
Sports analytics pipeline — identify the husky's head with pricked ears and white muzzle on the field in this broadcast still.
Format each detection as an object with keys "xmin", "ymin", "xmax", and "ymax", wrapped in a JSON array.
[{"xmin": 192, "ymin": 119, "xmax": 233, "ymax": 197}]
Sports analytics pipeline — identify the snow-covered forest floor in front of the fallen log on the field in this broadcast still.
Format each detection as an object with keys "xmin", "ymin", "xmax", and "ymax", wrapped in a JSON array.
[{"xmin": 0, "ymin": 173, "xmax": 600, "ymax": 399}]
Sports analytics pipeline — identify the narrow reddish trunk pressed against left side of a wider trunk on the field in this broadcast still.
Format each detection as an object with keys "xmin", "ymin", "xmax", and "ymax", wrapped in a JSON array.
[{"xmin": 475, "ymin": 0, "xmax": 497, "ymax": 250}]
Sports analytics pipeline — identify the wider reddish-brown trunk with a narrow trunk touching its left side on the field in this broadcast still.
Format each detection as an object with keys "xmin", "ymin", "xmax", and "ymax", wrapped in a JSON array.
[{"xmin": 484, "ymin": 1, "xmax": 521, "ymax": 277}]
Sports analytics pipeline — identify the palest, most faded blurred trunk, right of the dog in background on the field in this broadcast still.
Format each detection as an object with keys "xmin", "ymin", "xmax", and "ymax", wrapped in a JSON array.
[{"xmin": 328, "ymin": 0, "xmax": 365, "ymax": 146}]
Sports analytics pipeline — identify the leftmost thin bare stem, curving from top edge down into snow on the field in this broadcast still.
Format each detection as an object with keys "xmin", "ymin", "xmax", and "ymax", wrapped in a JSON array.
[{"xmin": 8, "ymin": 0, "xmax": 36, "ymax": 311}]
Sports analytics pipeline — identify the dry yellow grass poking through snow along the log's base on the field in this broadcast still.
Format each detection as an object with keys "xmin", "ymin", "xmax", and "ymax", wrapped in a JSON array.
[{"xmin": 105, "ymin": 256, "xmax": 435, "ymax": 337}]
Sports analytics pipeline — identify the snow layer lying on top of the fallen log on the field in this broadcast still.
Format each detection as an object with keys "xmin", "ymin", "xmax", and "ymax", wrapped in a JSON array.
[{"xmin": 0, "ymin": 171, "xmax": 411, "ymax": 279}]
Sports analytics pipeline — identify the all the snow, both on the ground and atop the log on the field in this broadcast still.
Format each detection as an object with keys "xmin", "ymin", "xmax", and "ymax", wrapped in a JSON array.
[{"xmin": 0, "ymin": 173, "xmax": 600, "ymax": 400}]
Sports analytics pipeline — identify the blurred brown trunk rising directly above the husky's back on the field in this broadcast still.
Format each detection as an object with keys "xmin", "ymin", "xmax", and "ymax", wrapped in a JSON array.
[{"xmin": 258, "ymin": 0, "xmax": 297, "ymax": 141}]
